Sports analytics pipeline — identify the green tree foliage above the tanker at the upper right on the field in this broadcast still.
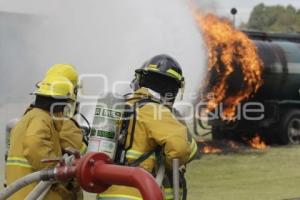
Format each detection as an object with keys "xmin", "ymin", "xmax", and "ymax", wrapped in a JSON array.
[{"xmin": 242, "ymin": 3, "xmax": 300, "ymax": 32}]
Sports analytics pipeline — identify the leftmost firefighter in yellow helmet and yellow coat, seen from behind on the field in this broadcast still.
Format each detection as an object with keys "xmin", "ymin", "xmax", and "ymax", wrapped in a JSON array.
[{"xmin": 6, "ymin": 76, "xmax": 75, "ymax": 200}]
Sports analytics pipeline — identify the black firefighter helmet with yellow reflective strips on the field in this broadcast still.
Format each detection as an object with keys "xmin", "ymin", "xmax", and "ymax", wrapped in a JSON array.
[{"xmin": 135, "ymin": 54, "xmax": 184, "ymax": 88}]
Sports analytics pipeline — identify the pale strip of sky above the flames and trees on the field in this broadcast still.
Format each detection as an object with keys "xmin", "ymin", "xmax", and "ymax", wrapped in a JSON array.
[{"xmin": 196, "ymin": 0, "xmax": 300, "ymax": 25}]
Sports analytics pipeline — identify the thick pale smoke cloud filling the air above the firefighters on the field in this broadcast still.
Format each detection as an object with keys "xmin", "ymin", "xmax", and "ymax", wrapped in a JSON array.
[{"xmin": 0, "ymin": 0, "xmax": 206, "ymax": 184}]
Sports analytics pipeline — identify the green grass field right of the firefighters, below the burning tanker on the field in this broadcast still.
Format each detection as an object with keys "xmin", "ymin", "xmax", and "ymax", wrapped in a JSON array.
[{"xmin": 187, "ymin": 146, "xmax": 300, "ymax": 200}]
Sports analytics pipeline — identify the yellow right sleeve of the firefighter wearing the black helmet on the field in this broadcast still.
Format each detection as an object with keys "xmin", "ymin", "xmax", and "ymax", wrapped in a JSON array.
[{"xmin": 138, "ymin": 104, "xmax": 190, "ymax": 166}]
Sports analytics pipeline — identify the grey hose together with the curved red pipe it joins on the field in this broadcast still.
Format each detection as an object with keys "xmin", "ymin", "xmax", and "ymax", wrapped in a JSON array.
[{"xmin": 0, "ymin": 153, "xmax": 163, "ymax": 200}]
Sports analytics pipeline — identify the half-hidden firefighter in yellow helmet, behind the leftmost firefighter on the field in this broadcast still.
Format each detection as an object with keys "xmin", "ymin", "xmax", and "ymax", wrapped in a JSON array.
[{"xmin": 45, "ymin": 64, "xmax": 87, "ymax": 154}]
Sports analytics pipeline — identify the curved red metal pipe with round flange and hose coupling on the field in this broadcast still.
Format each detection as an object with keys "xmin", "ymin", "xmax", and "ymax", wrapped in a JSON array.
[{"xmin": 55, "ymin": 153, "xmax": 163, "ymax": 200}]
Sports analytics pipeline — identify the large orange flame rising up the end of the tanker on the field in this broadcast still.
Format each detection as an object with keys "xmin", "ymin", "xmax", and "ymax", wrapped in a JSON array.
[{"xmin": 195, "ymin": 12, "xmax": 263, "ymax": 120}]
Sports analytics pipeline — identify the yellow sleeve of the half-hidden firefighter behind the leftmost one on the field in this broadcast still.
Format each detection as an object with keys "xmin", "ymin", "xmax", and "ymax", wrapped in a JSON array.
[{"xmin": 59, "ymin": 119, "xmax": 83, "ymax": 151}]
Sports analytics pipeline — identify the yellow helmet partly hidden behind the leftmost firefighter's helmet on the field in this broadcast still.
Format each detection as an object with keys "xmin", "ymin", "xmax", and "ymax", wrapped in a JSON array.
[{"xmin": 46, "ymin": 64, "xmax": 78, "ymax": 87}]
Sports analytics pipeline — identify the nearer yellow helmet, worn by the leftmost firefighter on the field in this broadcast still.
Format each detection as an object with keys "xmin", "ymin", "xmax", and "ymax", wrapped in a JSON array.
[{"xmin": 33, "ymin": 75, "xmax": 76, "ymax": 101}]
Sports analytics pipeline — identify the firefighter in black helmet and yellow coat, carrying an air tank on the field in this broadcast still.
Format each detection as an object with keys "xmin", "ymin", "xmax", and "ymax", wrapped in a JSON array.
[{"xmin": 97, "ymin": 55, "xmax": 197, "ymax": 200}]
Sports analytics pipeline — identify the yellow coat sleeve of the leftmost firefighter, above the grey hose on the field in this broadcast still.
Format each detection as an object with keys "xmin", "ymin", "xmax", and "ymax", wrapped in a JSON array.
[{"xmin": 23, "ymin": 117, "xmax": 59, "ymax": 170}]
